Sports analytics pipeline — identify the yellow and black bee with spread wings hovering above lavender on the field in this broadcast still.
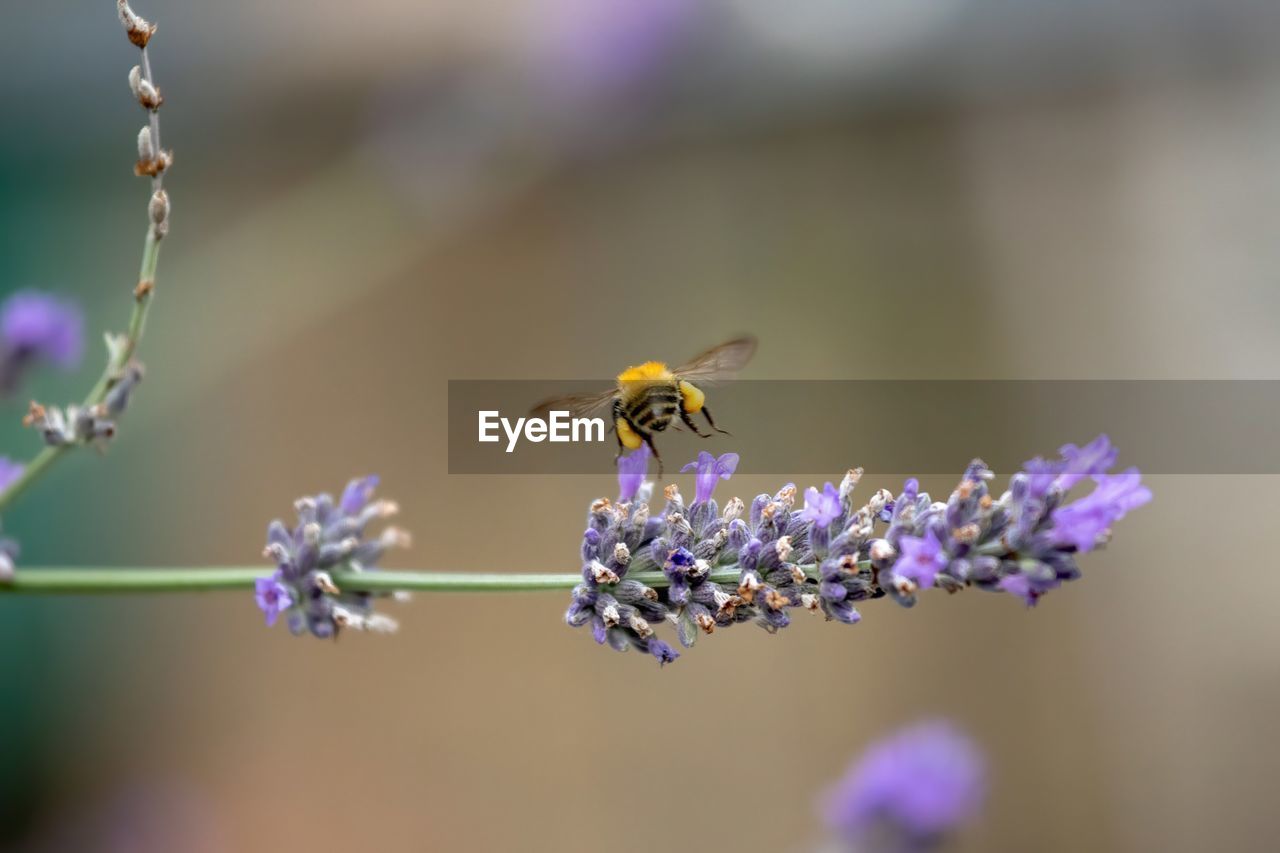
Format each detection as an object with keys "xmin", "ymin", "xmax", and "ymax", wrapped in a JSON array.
[{"xmin": 530, "ymin": 336, "xmax": 755, "ymax": 476}]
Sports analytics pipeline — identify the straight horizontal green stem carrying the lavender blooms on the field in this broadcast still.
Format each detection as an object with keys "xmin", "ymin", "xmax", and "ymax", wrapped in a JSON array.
[{"xmin": 0, "ymin": 566, "xmax": 829, "ymax": 594}]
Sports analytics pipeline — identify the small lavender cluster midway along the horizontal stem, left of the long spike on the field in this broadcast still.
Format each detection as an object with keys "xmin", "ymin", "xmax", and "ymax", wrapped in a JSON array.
[{"xmin": 256, "ymin": 476, "xmax": 408, "ymax": 638}]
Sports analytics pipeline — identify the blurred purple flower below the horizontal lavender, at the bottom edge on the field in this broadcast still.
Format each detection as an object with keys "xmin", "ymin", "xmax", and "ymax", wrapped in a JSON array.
[{"xmin": 824, "ymin": 721, "xmax": 986, "ymax": 848}]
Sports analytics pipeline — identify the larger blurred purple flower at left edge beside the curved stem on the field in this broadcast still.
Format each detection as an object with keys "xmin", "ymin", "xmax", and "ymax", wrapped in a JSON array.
[{"xmin": 0, "ymin": 291, "xmax": 84, "ymax": 393}]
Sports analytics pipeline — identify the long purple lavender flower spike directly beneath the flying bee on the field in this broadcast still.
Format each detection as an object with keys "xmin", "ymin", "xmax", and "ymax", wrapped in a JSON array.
[{"xmin": 564, "ymin": 435, "xmax": 1151, "ymax": 662}]
